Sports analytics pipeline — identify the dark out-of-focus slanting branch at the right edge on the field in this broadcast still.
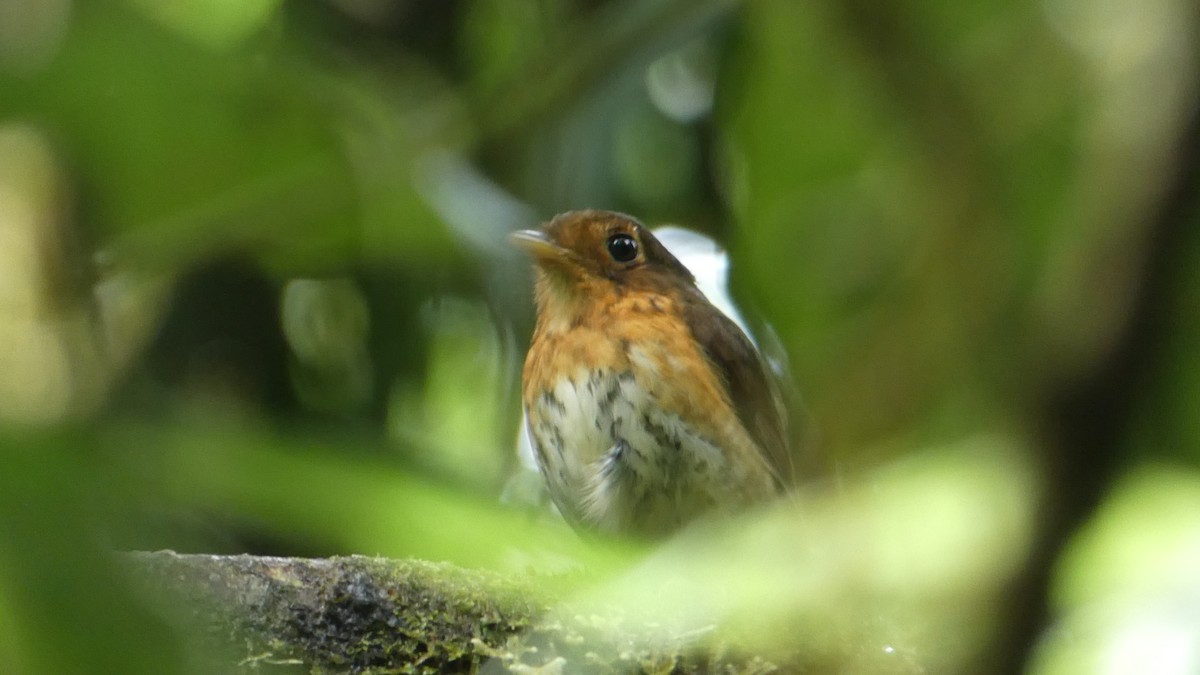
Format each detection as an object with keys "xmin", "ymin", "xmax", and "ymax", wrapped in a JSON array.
[{"xmin": 992, "ymin": 108, "xmax": 1200, "ymax": 673}]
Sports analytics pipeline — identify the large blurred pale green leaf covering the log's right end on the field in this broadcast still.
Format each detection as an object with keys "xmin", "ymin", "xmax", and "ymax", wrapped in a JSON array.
[{"xmin": 569, "ymin": 438, "xmax": 1034, "ymax": 673}]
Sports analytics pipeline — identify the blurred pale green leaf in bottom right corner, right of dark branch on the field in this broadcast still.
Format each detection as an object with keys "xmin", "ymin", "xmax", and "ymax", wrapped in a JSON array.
[{"xmin": 1032, "ymin": 466, "xmax": 1200, "ymax": 675}]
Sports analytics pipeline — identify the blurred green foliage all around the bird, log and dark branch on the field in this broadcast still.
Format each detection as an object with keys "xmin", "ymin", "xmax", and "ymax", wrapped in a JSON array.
[{"xmin": 0, "ymin": 0, "xmax": 1200, "ymax": 673}]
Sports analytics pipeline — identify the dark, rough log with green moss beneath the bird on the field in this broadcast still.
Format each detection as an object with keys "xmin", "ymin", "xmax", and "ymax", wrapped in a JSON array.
[{"xmin": 130, "ymin": 551, "xmax": 775, "ymax": 674}]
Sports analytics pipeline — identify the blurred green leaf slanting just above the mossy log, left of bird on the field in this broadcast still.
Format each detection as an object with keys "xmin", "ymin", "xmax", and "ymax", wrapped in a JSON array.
[{"xmin": 106, "ymin": 420, "xmax": 628, "ymax": 571}]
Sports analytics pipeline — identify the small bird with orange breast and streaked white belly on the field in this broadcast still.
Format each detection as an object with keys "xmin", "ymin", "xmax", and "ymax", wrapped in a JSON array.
[{"xmin": 512, "ymin": 210, "xmax": 794, "ymax": 537}]
